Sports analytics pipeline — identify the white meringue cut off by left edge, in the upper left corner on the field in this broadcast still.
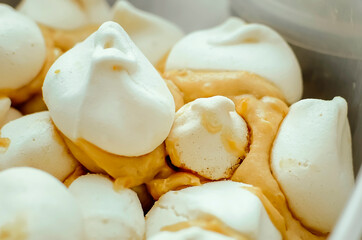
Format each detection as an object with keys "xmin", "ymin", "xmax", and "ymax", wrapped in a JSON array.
[{"xmin": 0, "ymin": 4, "xmax": 46, "ymax": 90}]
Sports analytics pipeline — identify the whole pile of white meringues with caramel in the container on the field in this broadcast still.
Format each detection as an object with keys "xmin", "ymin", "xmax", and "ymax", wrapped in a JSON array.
[{"xmin": 0, "ymin": 0, "xmax": 354, "ymax": 240}]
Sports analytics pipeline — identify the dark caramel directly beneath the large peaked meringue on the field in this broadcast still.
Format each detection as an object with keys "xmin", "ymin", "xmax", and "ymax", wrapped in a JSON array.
[{"xmin": 63, "ymin": 135, "xmax": 168, "ymax": 189}]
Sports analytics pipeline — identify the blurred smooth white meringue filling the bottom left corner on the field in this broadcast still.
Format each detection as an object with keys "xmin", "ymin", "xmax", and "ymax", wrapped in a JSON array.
[{"xmin": 0, "ymin": 167, "xmax": 83, "ymax": 240}]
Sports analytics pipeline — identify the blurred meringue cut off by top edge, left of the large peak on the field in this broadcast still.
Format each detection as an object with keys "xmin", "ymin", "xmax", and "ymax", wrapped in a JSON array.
[{"xmin": 18, "ymin": 0, "xmax": 111, "ymax": 30}]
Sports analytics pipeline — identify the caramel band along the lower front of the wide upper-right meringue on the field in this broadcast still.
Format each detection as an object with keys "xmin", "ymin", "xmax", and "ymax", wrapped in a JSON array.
[{"xmin": 163, "ymin": 70, "xmax": 285, "ymax": 103}]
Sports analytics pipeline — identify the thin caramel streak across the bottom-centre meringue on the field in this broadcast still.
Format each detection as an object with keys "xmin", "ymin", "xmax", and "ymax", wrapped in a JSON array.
[{"xmin": 161, "ymin": 214, "xmax": 252, "ymax": 240}]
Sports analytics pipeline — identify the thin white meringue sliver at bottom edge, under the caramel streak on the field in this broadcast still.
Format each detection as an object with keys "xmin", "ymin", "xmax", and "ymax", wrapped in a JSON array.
[{"xmin": 149, "ymin": 227, "xmax": 234, "ymax": 240}]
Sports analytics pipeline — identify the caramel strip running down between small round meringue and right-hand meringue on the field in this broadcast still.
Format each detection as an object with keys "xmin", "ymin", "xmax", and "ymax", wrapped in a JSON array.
[{"xmin": 231, "ymin": 96, "xmax": 325, "ymax": 240}]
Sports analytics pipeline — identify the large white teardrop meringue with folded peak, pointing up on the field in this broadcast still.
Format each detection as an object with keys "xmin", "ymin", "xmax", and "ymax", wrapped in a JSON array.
[{"xmin": 43, "ymin": 22, "xmax": 175, "ymax": 156}]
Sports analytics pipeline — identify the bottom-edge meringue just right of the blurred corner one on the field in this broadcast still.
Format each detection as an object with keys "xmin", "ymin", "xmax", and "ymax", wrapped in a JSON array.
[{"xmin": 69, "ymin": 174, "xmax": 145, "ymax": 240}]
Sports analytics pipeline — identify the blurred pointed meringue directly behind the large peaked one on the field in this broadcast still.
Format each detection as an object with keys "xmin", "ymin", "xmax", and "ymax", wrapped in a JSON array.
[{"xmin": 113, "ymin": 1, "xmax": 183, "ymax": 65}]
